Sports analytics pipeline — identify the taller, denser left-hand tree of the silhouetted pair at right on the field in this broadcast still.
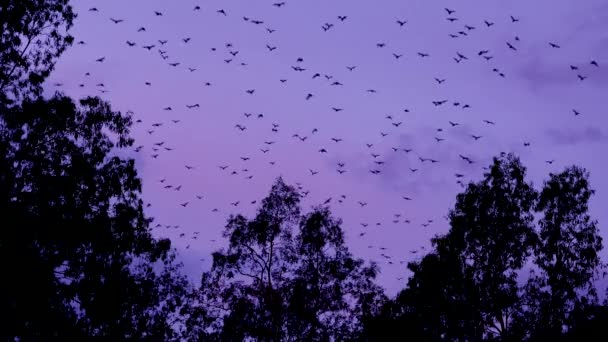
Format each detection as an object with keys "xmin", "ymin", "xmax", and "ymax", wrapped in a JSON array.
[{"xmin": 380, "ymin": 155, "xmax": 536, "ymax": 341}]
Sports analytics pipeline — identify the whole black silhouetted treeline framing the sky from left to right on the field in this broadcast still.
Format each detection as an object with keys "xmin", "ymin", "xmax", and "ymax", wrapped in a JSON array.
[{"xmin": 0, "ymin": 0, "xmax": 608, "ymax": 341}]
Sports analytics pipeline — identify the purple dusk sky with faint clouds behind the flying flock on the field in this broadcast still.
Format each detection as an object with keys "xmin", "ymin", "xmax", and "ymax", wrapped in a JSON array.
[{"xmin": 47, "ymin": 0, "xmax": 608, "ymax": 294}]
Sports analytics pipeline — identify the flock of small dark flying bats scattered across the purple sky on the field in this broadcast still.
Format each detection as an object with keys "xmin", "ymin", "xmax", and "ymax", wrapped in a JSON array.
[{"xmin": 55, "ymin": 1, "xmax": 600, "ymax": 280}]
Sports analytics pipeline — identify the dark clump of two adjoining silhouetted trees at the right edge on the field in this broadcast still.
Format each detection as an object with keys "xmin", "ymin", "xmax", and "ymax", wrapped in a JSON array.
[{"xmin": 365, "ymin": 154, "xmax": 608, "ymax": 341}]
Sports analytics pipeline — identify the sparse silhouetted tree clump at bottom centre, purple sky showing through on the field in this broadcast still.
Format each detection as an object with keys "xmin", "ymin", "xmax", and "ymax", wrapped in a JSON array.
[{"xmin": 191, "ymin": 178, "xmax": 381, "ymax": 341}]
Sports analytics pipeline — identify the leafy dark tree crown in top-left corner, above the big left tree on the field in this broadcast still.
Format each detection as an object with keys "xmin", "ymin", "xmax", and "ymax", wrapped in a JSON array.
[{"xmin": 0, "ymin": 0, "xmax": 75, "ymax": 103}]
